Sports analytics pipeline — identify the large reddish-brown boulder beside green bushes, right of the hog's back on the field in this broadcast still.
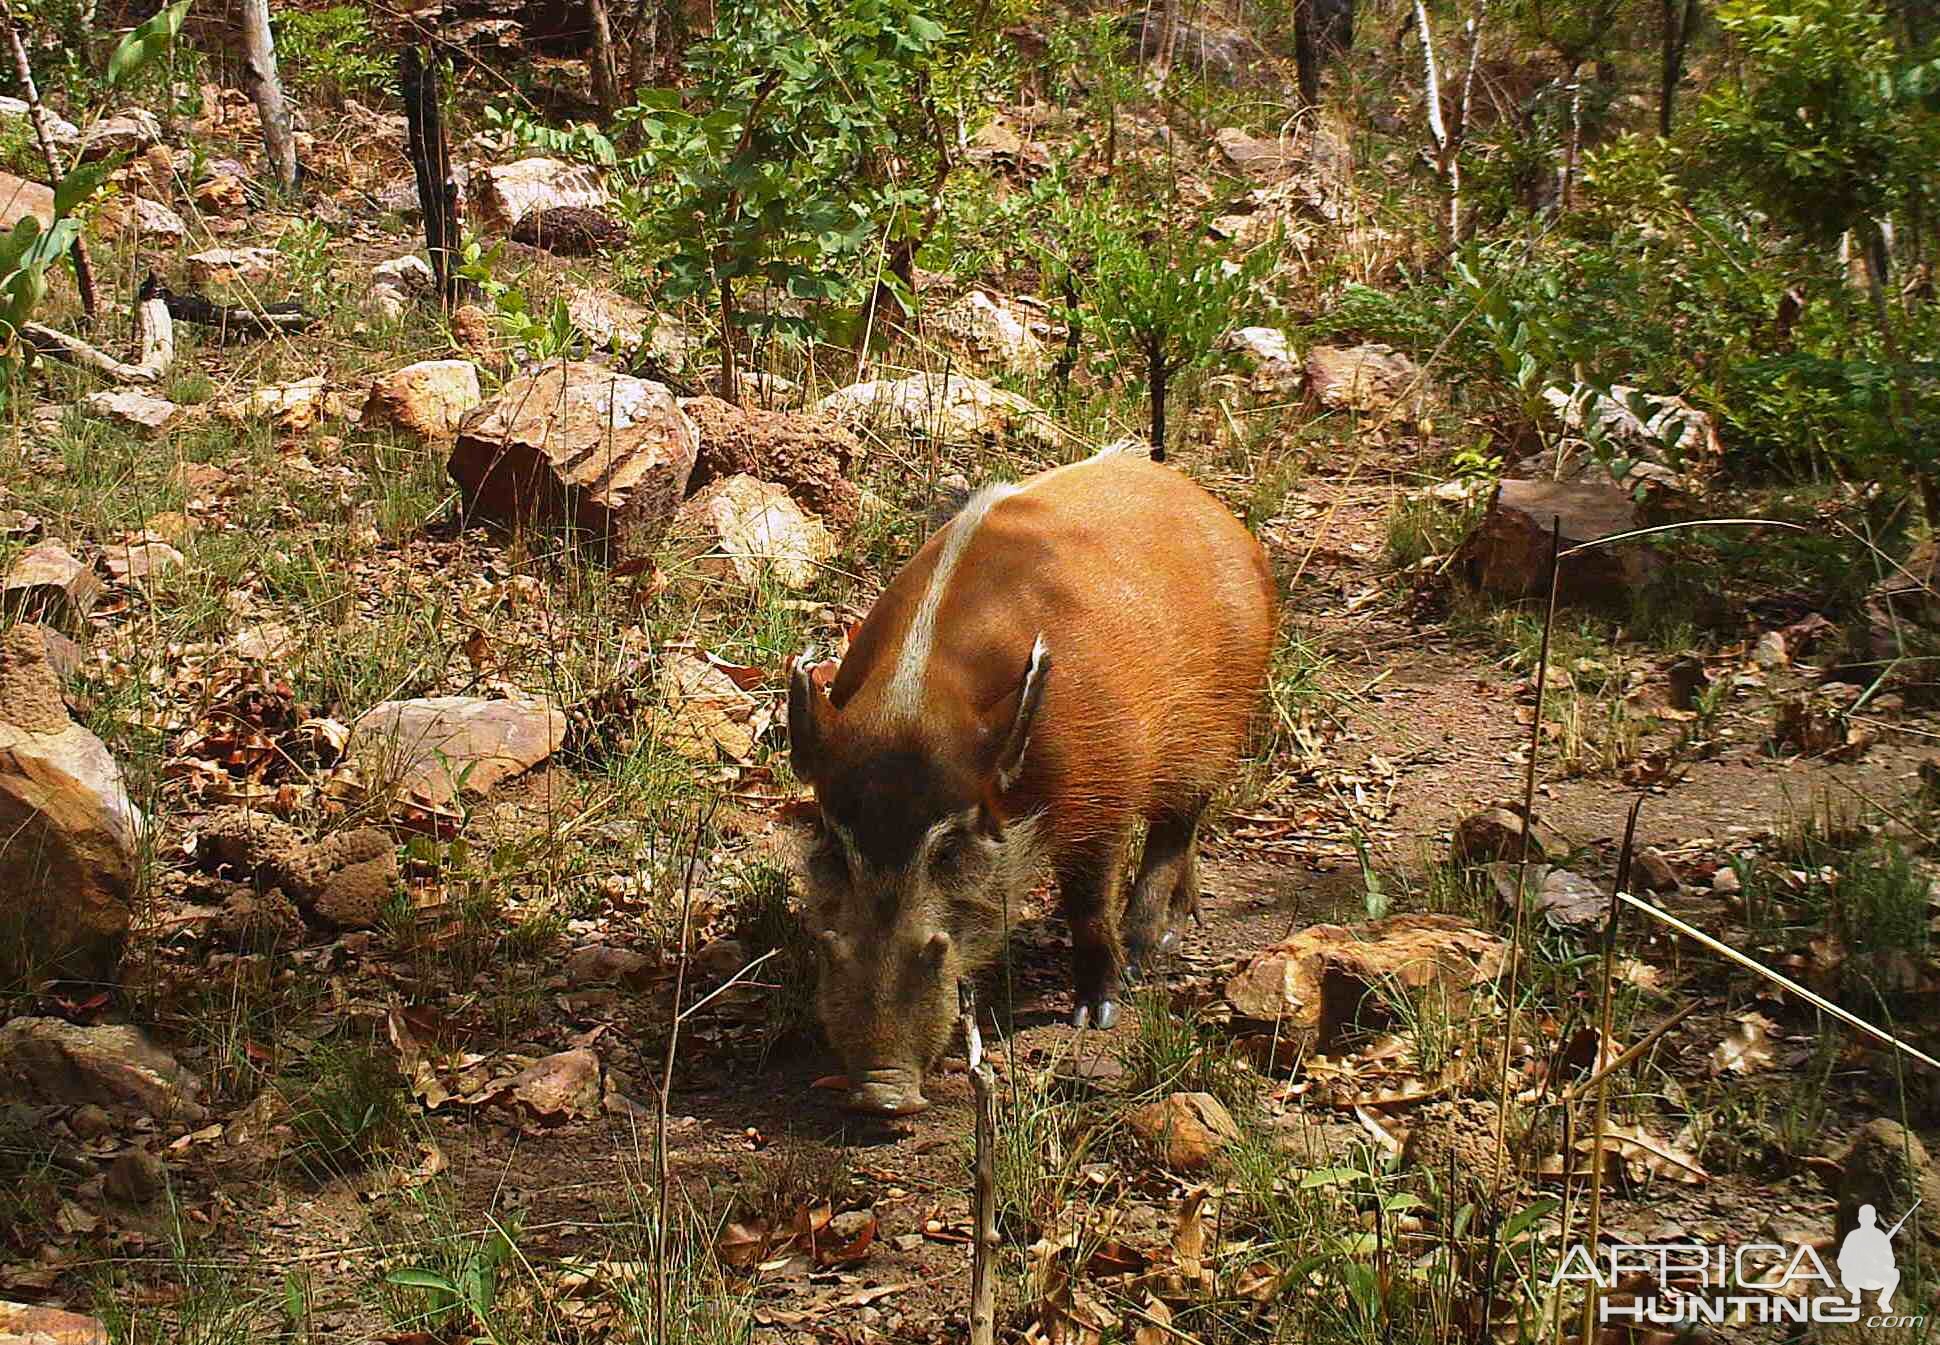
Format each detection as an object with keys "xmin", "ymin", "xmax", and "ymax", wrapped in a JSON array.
[{"xmin": 1457, "ymin": 479, "xmax": 1661, "ymax": 604}]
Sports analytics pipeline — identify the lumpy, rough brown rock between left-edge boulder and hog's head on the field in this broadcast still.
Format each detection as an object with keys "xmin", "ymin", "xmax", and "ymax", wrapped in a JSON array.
[{"xmin": 196, "ymin": 807, "xmax": 398, "ymax": 935}]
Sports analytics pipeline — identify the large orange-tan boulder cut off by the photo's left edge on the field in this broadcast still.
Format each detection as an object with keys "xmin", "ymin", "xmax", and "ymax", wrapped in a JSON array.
[{"xmin": 0, "ymin": 625, "xmax": 142, "ymax": 984}]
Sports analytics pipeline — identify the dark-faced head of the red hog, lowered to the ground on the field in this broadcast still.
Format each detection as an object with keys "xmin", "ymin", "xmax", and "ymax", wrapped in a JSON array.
[{"xmin": 788, "ymin": 644, "xmax": 1050, "ymax": 1116}]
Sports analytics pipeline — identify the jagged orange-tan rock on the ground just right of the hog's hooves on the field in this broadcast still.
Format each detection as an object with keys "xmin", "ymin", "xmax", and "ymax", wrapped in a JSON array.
[{"xmin": 1226, "ymin": 914, "xmax": 1507, "ymax": 1046}]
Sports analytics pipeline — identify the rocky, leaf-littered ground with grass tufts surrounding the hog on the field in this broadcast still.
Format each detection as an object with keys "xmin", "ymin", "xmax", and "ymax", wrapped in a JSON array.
[{"xmin": 0, "ymin": 18, "xmax": 1940, "ymax": 1343}]
